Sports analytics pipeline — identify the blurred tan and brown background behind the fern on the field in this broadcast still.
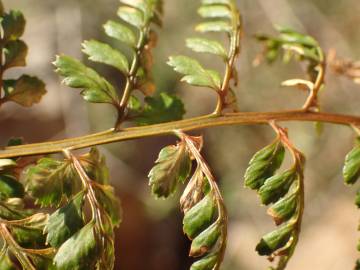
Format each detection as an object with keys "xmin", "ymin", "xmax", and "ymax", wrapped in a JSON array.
[{"xmin": 0, "ymin": 0, "xmax": 360, "ymax": 270}]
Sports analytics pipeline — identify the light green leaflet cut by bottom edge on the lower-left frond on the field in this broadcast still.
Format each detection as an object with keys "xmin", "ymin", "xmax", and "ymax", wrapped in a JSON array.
[{"xmin": 54, "ymin": 221, "xmax": 99, "ymax": 270}]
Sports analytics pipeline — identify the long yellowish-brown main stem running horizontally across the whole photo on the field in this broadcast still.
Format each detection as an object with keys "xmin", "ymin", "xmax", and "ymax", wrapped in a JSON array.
[{"xmin": 0, "ymin": 110, "xmax": 360, "ymax": 159}]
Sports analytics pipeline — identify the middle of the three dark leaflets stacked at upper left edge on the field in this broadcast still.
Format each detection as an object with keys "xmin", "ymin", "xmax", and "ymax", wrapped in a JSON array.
[{"xmin": 4, "ymin": 40, "xmax": 28, "ymax": 69}]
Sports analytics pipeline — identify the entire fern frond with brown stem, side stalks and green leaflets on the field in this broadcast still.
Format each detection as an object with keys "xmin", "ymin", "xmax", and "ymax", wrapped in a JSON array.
[{"xmin": 0, "ymin": 0, "xmax": 360, "ymax": 270}]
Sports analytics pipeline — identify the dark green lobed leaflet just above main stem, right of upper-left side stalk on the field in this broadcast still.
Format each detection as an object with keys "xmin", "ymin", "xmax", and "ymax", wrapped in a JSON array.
[{"xmin": 129, "ymin": 93, "xmax": 185, "ymax": 126}]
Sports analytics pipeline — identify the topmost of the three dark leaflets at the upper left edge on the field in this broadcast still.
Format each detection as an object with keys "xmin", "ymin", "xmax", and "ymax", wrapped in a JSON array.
[{"xmin": 1, "ymin": 10, "xmax": 25, "ymax": 41}]
